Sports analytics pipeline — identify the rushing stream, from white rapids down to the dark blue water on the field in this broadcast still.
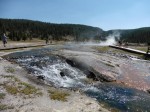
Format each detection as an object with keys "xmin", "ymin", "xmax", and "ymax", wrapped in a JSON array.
[{"xmin": 3, "ymin": 49, "xmax": 150, "ymax": 112}]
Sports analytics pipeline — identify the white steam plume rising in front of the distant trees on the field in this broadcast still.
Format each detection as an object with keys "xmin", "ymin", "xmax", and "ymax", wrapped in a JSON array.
[{"xmin": 100, "ymin": 31, "xmax": 120, "ymax": 46}]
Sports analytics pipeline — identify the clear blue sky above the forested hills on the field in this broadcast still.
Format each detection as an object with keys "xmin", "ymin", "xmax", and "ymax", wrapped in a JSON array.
[{"xmin": 0, "ymin": 0, "xmax": 150, "ymax": 30}]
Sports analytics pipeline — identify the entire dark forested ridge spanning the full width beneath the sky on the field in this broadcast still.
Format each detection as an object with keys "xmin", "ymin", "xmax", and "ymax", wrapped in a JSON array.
[{"xmin": 0, "ymin": 19, "xmax": 150, "ymax": 43}]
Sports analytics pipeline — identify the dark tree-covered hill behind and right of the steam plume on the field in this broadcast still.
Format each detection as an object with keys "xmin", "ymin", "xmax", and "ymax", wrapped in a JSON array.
[{"xmin": 103, "ymin": 27, "xmax": 150, "ymax": 43}]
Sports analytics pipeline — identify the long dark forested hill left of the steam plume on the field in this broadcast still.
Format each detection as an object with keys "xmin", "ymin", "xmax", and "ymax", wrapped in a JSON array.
[{"xmin": 0, "ymin": 19, "xmax": 103, "ymax": 41}]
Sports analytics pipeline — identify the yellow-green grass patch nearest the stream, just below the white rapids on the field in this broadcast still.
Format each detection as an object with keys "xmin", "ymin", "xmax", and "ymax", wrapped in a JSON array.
[{"xmin": 48, "ymin": 90, "xmax": 70, "ymax": 101}]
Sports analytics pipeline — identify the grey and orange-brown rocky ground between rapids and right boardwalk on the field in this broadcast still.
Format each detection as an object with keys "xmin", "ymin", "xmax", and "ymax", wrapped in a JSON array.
[{"xmin": 54, "ymin": 45, "xmax": 150, "ymax": 91}]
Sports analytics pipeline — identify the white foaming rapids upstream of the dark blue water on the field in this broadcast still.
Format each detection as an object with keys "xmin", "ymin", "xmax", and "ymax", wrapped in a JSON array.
[{"xmin": 16, "ymin": 55, "xmax": 86, "ymax": 88}]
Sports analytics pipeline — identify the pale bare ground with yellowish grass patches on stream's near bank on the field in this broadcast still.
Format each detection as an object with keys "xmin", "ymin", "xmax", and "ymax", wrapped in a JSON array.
[{"xmin": 0, "ymin": 44, "xmax": 108, "ymax": 112}]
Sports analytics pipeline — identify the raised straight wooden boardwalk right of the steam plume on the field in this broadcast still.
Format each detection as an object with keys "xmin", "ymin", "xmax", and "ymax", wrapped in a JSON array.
[{"xmin": 109, "ymin": 45, "xmax": 150, "ymax": 56}]
